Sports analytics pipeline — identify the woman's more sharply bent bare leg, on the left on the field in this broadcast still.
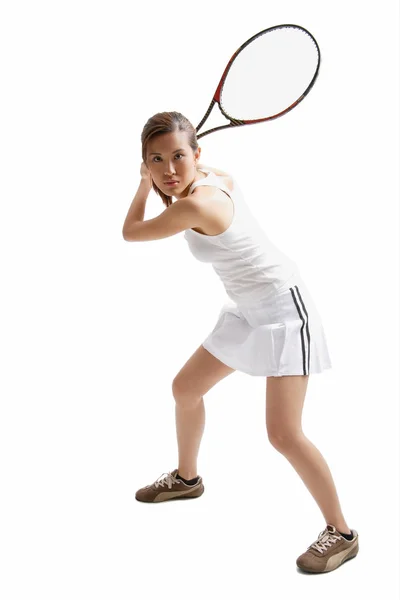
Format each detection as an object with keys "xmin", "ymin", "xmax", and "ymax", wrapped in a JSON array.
[{"xmin": 172, "ymin": 346, "xmax": 235, "ymax": 479}]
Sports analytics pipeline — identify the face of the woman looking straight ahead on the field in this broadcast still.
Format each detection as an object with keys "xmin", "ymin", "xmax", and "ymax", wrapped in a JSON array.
[{"xmin": 146, "ymin": 131, "xmax": 201, "ymax": 199}]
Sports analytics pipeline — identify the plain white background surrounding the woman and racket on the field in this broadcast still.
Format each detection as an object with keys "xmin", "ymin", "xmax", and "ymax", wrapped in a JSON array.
[{"xmin": 0, "ymin": 0, "xmax": 399, "ymax": 600}]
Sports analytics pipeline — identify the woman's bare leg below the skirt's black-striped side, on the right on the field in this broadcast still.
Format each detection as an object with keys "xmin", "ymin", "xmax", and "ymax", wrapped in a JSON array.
[{"xmin": 266, "ymin": 375, "xmax": 351, "ymax": 534}]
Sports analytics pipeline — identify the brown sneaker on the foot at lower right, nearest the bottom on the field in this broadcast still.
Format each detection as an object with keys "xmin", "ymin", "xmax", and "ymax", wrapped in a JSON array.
[{"xmin": 296, "ymin": 525, "xmax": 358, "ymax": 573}]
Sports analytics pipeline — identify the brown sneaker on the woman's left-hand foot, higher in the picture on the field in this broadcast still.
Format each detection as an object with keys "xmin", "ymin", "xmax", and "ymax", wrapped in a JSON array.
[{"xmin": 135, "ymin": 469, "xmax": 204, "ymax": 502}]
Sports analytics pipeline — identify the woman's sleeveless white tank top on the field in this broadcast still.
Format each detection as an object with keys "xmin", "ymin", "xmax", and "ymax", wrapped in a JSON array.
[{"xmin": 184, "ymin": 168, "xmax": 298, "ymax": 307}]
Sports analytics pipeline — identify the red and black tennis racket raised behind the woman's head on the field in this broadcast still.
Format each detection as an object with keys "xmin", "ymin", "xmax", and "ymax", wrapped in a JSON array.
[{"xmin": 196, "ymin": 25, "xmax": 321, "ymax": 139}]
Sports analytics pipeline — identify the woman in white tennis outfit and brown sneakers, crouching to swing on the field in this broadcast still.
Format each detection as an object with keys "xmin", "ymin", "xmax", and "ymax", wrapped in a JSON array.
[{"xmin": 123, "ymin": 112, "xmax": 358, "ymax": 572}]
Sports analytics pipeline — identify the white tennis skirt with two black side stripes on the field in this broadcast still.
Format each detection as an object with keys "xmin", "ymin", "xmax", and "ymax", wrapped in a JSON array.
[{"xmin": 202, "ymin": 275, "xmax": 332, "ymax": 377}]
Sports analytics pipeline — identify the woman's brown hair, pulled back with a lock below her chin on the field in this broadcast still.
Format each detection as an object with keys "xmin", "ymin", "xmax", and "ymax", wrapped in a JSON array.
[{"xmin": 141, "ymin": 111, "xmax": 199, "ymax": 208}]
